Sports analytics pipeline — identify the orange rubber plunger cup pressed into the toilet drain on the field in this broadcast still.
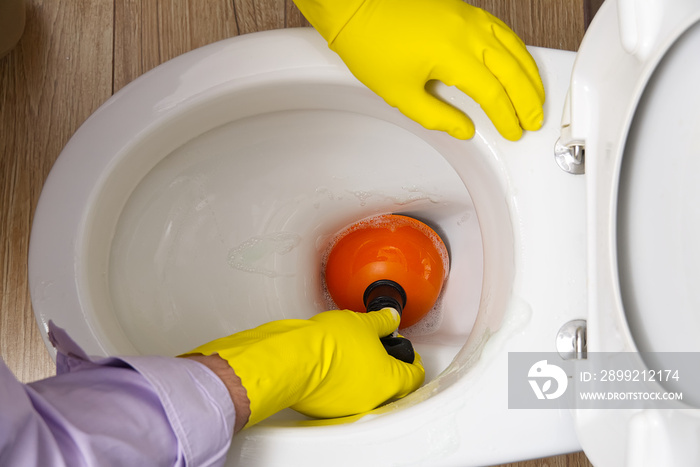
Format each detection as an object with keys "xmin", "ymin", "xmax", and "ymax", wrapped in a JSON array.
[{"xmin": 326, "ymin": 214, "xmax": 449, "ymax": 328}]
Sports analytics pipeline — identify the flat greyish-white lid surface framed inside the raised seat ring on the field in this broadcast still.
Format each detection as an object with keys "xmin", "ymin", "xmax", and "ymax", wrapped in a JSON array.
[{"xmin": 617, "ymin": 16, "xmax": 700, "ymax": 352}]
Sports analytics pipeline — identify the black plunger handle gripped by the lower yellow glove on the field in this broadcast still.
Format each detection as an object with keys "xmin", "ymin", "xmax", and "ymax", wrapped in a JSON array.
[{"xmin": 363, "ymin": 280, "xmax": 416, "ymax": 363}]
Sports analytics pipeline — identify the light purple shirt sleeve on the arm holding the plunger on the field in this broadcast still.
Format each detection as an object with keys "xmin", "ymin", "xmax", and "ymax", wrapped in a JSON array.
[{"xmin": 0, "ymin": 324, "xmax": 235, "ymax": 466}]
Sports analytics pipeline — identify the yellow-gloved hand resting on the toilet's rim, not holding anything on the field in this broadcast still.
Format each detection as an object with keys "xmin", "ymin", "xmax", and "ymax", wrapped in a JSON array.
[{"xmin": 294, "ymin": 0, "xmax": 544, "ymax": 141}]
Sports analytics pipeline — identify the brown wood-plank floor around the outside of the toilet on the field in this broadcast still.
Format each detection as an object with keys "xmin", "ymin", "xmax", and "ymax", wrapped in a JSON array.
[{"xmin": 0, "ymin": 0, "xmax": 600, "ymax": 467}]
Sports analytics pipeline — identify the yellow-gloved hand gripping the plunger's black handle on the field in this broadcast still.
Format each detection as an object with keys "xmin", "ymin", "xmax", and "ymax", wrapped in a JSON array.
[{"xmin": 180, "ymin": 308, "xmax": 425, "ymax": 426}]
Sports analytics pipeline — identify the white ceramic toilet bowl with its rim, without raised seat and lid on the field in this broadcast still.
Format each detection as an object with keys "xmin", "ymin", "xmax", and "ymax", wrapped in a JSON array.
[{"xmin": 29, "ymin": 2, "xmax": 697, "ymax": 466}]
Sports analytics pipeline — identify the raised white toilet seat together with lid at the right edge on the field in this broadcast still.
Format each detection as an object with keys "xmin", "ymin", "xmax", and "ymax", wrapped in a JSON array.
[{"xmin": 563, "ymin": 0, "xmax": 700, "ymax": 466}]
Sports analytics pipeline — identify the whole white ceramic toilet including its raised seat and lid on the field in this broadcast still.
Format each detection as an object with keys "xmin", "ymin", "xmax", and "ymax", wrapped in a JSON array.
[{"xmin": 29, "ymin": 0, "xmax": 700, "ymax": 466}]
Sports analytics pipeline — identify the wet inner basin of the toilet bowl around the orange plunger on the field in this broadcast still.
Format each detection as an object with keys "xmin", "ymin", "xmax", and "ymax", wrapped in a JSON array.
[{"xmin": 104, "ymin": 106, "xmax": 483, "ymax": 388}]
